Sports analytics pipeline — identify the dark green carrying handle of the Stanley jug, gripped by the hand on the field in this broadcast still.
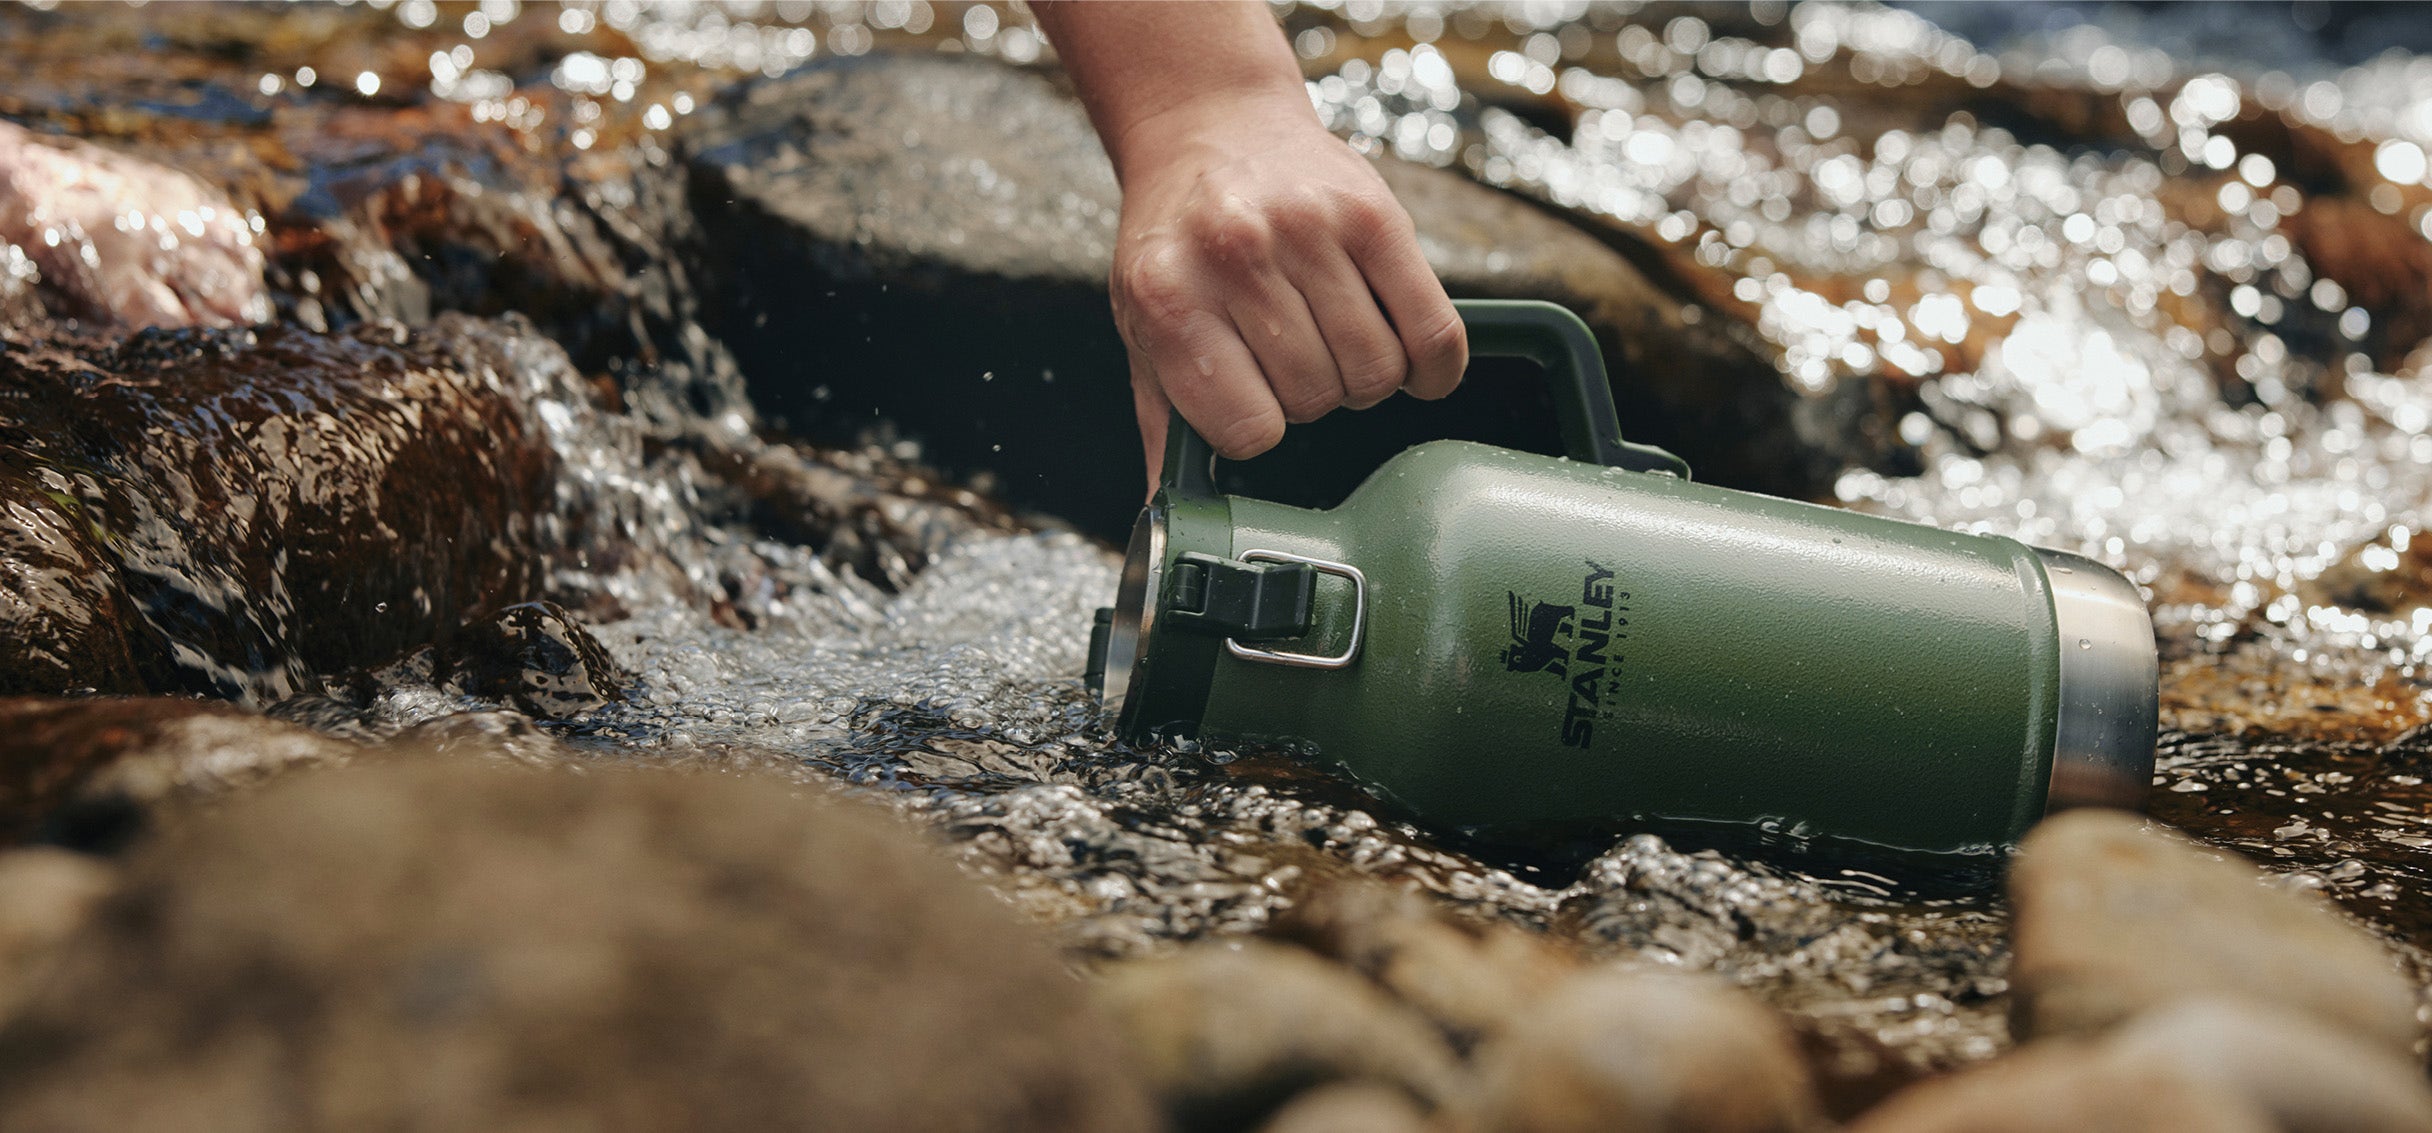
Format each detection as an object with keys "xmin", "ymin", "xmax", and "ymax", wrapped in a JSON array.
[{"xmin": 1158, "ymin": 299, "xmax": 1688, "ymax": 496}]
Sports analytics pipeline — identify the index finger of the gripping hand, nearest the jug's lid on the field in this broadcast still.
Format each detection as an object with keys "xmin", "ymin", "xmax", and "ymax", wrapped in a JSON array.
[{"xmin": 1124, "ymin": 272, "xmax": 1284, "ymax": 460}]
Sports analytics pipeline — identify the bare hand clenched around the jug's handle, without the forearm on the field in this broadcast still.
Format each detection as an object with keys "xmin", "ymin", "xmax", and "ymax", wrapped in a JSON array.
[{"xmin": 1109, "ymin": 94, "xmax": 1469, "ymax": 486}]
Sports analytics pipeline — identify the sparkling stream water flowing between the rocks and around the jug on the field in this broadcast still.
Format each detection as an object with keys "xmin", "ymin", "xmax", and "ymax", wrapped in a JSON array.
[{"xmin": 0, "ymin": 0, "xmax": 2432, "ymax": 1094}]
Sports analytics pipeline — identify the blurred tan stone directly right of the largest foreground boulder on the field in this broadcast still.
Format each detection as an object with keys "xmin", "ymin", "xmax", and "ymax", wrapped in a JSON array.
[{"xmin": 1099, "ymin": 941, "xmax": 1457, "ymax": 1128}]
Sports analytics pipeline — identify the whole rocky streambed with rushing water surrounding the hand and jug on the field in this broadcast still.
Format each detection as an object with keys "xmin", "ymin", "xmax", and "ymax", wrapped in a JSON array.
[{"xmin": 0, "ymin": 0, "xmax": 2432, "ymax": 1131}]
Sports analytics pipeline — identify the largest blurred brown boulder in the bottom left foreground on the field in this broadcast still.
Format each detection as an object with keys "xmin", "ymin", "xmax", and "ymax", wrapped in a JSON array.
[{"xmin": 0, "ymin": 759, "xmax": 1155, "ymax": 1131}]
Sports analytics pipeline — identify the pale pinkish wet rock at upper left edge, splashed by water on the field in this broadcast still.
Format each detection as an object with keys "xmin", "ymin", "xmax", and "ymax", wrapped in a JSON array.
[{"xmin": 0, "ymin": 122, "xmax": 270, "ymax": 328}]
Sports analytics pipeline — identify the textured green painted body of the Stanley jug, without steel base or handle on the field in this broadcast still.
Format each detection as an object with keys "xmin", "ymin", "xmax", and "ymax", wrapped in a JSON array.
[{"xmin": 1170, "ymin": 440, "xmax": 2060, "ymax": 851}]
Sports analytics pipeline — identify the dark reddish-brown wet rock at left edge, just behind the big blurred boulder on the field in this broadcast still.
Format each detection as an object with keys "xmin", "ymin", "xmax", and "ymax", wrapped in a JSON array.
[{"xmin": 0, "ymin": 695, "xmax": 355, "ymax": 846}]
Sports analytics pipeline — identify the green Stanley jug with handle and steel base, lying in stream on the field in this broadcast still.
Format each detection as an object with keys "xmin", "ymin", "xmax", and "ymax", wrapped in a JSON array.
[{"xmin": 1090, "ymin": 301, "xmax": 2157, "ymax": 851}]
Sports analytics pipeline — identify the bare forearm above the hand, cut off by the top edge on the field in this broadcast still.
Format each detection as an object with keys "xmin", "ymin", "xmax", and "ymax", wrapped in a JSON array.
[{"xmin": 1031, "ymin": 0, "xmax": 1316, "ymax": 185}]
